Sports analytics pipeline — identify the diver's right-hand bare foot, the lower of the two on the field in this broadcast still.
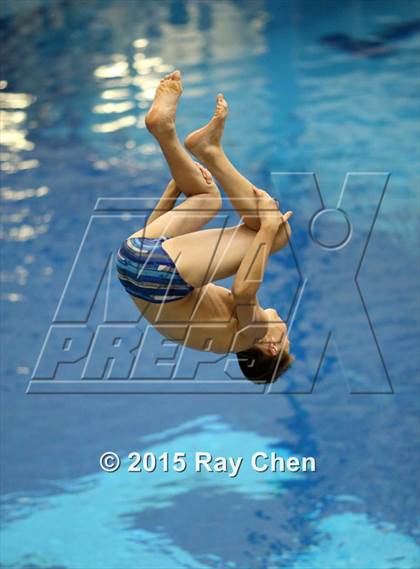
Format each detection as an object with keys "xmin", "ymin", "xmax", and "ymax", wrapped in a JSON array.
[{"xmin": 184, "ymin": 93, "xmax": 229, "ymax": 161}]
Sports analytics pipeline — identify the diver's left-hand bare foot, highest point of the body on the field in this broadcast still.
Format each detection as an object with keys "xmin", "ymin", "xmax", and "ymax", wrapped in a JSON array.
[{"xmin": 145, "ymin": 71, "xmax": 182, "ymax": 135}]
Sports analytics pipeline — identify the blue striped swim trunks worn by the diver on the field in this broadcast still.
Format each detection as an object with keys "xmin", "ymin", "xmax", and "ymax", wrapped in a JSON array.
[{"xmin": 116, "ymin": 237, "xmax": 194, "ymax": 304}]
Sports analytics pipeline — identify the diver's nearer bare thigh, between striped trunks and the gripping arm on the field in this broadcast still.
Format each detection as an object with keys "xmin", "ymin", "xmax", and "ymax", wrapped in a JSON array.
[{"xmin": 163, "ymin": 224, "xmax": 287, "ymax": 287}]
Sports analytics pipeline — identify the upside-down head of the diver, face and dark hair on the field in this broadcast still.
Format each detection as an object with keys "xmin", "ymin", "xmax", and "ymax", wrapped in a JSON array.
[{"xmin": 237, "ymin": 308, "xmax": 294, "ymax": 383}]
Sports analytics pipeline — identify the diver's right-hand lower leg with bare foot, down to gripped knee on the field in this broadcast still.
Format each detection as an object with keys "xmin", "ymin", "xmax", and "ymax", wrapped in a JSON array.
[{"xmin": 185, "ymin": 94, "xmax": 290, "ymax": 245}]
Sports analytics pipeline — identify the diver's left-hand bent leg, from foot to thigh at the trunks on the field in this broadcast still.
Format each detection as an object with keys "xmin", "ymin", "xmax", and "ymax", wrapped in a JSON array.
[{"xmin": 135, "ymin": 71, "xmax": 221, "ymax": 237}]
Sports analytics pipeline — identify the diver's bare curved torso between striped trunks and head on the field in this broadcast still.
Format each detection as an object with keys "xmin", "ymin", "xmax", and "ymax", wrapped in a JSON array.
[{"xmin": 132, "ymin": 283, "xmax": 253, "ymax": 354}]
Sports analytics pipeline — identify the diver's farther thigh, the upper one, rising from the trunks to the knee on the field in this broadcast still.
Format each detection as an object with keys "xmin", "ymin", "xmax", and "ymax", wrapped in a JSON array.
[{"xmin": 132, "ymin": 194, "xmax": 220, "ymax": 238}]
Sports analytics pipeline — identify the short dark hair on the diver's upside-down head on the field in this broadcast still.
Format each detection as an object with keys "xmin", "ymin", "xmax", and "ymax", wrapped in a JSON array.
[{"xmin": 236, "ymin": 348, "xmax": 295, "ymax": 383}]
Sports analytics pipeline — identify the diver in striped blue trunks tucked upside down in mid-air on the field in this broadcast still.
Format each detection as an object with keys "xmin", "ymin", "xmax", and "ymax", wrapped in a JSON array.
[{"xmin": 116, "ymin": 71, "xmax": 293, "ymax": 383}]
